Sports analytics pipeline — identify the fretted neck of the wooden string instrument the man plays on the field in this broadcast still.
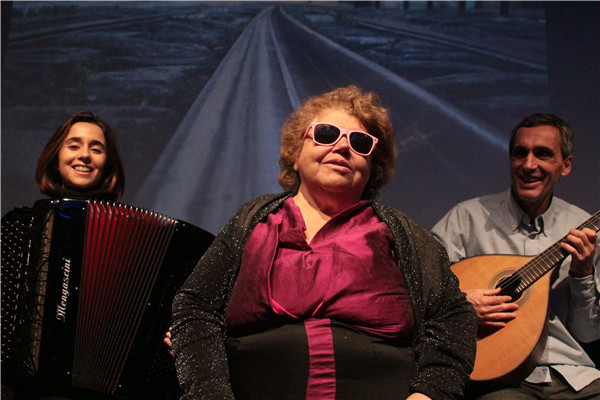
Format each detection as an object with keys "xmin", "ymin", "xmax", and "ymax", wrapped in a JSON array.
[{"xmin": 515, "ymin": 211, "xmax": 600, "ymax": 293}]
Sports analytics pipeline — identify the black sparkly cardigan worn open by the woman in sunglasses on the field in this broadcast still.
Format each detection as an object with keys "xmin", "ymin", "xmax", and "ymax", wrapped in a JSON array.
[{"xmin": 172, "ymin": 193, "xmax": 477, "ymax": 400}]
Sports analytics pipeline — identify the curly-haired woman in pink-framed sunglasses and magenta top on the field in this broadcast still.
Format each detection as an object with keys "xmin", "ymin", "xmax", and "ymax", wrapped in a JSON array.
[{"xmin": 172, "ymin": 86, "xmax": 476, "ymax": 400}]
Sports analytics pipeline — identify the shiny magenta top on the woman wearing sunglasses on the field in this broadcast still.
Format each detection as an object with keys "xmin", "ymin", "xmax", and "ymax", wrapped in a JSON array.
[{"xmin": 226, "ymin": 198, "xmax": 414, "ymax": 399}]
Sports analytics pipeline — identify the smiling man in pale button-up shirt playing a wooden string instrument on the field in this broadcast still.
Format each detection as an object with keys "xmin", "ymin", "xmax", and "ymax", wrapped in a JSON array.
[{"xmin": 432, "ymin": 114, "xmax": 600, "ymax": 400}]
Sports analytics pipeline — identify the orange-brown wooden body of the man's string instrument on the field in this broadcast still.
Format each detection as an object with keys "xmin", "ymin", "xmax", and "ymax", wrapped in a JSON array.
[{"xmin": 451, "ymin": 255, "xmax": 552, "ymax": 384}]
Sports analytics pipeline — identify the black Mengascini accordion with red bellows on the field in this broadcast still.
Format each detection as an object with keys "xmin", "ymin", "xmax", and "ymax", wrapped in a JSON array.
[{"xmin": 1, "ymin": 199, "xmax": 214, "ymax": 398}]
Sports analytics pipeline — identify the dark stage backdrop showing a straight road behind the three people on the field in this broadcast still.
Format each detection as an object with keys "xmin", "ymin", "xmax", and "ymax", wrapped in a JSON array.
[{"xmin": 2, "ymin": 1, "xmax": 600, "ymax": 233}]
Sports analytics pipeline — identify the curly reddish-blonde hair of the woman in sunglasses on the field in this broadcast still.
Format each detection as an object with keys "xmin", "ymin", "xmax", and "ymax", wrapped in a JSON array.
[{"xmin": 278, "ymin": 85, "xmax": 396, "ymax": 199}]
